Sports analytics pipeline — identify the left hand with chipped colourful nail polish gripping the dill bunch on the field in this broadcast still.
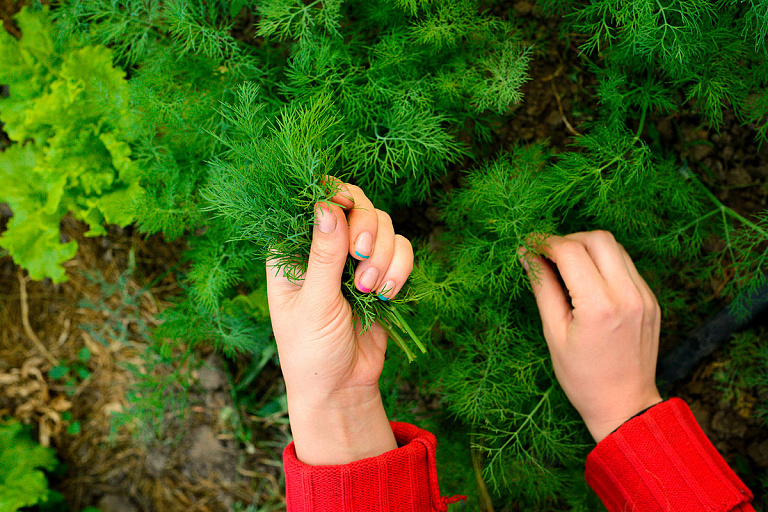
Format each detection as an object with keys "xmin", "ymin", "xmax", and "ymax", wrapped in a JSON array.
[{"xmin": 267, "ymin": 182, "xmax": 413, "ymax": 465}]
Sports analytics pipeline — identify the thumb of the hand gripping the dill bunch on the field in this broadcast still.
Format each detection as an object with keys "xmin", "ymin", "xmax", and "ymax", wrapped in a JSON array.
[{"xmin": 301, "ymin": 203, "xmax": 349, "ymax": 297}]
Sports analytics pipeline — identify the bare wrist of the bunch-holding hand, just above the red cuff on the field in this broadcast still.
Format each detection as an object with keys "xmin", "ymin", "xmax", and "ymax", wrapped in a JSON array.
[{"xmin": 288, "ymin": 388, "xmax": 397, "ymax": 466}]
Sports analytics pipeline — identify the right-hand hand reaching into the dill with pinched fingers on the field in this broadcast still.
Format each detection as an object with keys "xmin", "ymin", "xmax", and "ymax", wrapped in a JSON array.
[{"xmin": 521, "ymin": 231, "xmax": 661, "ymax": 442}]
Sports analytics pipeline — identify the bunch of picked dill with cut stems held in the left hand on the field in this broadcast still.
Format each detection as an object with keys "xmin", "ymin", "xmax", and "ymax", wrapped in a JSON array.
[{"xmin": 205, "ymin": 84, "xmax": 423, "ymax": 359}]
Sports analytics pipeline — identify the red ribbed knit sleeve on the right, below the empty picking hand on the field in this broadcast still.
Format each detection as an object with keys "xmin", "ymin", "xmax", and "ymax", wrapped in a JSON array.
[{"xmin": 586, "ymin": 398, "xmax": 754, "ymax": 512}]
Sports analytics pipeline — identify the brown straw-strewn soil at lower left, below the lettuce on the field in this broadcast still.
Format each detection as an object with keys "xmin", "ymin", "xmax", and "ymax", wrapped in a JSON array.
[{"xmin": 0, "ymin": 216, "xmax": 286, "ymax": 512}]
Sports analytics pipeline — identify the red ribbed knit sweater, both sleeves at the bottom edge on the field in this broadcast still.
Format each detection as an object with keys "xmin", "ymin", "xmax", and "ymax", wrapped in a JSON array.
[{"xmin": 283, "ymin": 398, "xmax": 754, "ymax": 512}]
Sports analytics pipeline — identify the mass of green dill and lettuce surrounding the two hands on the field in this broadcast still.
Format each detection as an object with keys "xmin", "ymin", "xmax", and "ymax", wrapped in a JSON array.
[{"xmin": 0, "ymin": 0, "xmax": 768, "ymax": 511}]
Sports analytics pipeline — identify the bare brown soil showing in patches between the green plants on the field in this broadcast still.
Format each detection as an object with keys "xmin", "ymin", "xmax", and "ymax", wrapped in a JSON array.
[{"xmin": 0, "ymin": 0, "xmax": 768, "ymax": 512}]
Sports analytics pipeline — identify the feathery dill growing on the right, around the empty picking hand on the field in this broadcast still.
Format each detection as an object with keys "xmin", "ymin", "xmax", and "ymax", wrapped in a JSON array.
[{"xmin": 385, "ymin": 1, "xmax": 768, "ymax": 510}]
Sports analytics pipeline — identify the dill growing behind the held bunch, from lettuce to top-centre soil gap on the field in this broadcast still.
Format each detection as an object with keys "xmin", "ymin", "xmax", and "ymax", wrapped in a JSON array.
[{"xmin": 46, "ymin": 0, "xmax": 530, "ymax": 353}]
